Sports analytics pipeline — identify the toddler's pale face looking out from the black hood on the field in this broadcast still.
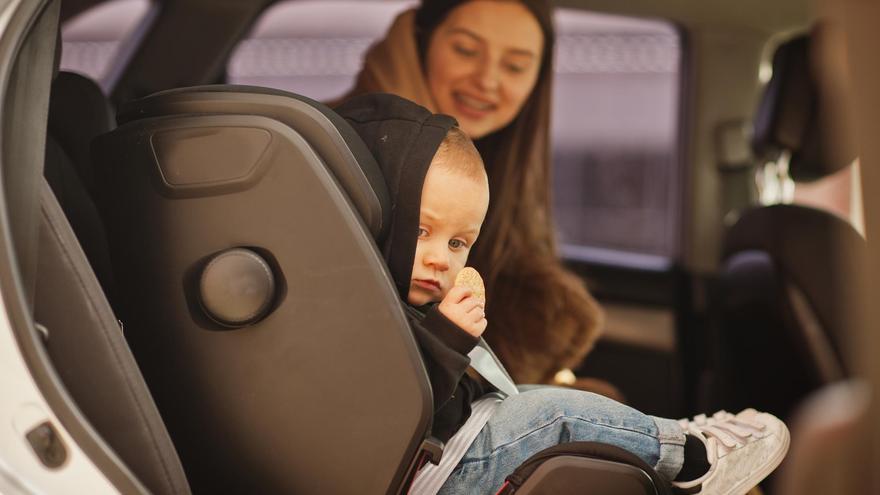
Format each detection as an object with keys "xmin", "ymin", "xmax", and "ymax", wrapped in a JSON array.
[{"xmin": 407, "ymin": 158, "xmax": 489, "ymax": 306}]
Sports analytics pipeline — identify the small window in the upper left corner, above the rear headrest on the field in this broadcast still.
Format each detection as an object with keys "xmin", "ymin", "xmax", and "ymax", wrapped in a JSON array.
[{"xmin": 61, "ymin": 0, "xmax": 155, "ymax": 93}]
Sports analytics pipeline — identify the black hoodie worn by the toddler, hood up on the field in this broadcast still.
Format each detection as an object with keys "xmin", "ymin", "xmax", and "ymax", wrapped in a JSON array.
[{"xmin": 336, "ymin": 94, "xmax": 484, "ymax": 442}]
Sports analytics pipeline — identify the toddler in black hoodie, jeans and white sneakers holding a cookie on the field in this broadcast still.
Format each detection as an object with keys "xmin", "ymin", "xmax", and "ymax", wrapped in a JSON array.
[{"xmin": 336, "ymin": 94, "xmax": 789, "ymax": 494}]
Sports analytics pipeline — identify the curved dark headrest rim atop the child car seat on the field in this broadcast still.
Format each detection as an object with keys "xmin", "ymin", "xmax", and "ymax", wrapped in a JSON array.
[{"xmin": 117, "ymin": 85, "xmax": 391, "ymax": 243}]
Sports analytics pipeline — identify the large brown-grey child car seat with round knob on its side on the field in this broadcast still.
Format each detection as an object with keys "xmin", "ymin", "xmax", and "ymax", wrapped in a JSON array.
[{"xmin": 93, "ymin": 86, "xmax": 668, "ymax": 495}]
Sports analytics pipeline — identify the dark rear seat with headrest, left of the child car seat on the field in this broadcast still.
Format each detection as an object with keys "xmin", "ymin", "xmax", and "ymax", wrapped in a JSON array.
[{"xmin": 34, "ymin": 73, "xmax": 190, "ymax": 494}]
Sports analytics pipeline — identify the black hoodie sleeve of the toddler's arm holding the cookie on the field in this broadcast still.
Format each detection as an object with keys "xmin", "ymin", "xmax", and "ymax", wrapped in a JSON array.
[{"xmin": 412, "ymin": 306, "xmax": 483, "ymax": 442}]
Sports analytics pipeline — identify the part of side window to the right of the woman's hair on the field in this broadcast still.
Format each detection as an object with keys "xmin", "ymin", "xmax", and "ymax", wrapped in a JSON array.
[{"xmin": 552, "ymin": 9, "xmax": 683, "ymax": 268}]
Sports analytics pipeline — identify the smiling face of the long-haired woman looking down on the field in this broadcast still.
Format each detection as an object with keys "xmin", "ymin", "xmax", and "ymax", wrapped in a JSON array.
[{"xmin": 426, "ymin": 0, "xmax": 544, "ymax": 139}]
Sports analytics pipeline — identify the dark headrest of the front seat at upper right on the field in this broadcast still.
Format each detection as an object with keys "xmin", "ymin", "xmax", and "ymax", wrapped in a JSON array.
[{"xmin": 752, "ymin": 35, "xmax": 855, "ymax": 181}]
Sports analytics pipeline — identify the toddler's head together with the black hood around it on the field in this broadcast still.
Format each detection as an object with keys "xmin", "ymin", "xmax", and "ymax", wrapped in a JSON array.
[{"xmin": 336, "ymin": 93, "xmax": 489, "ymax": 306}]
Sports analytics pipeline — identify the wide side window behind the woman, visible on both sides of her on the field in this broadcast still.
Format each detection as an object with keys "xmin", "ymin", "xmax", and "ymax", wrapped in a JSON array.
[{"xmin": 227, "ymin": 0, "xmax": 682, "ymax": 272}]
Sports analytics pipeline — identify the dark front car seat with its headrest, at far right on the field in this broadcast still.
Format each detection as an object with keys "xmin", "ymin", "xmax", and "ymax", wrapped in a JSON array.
[{"xmin": 711, "ymin": 37, "xmax": 866, "ymax": 417}]
